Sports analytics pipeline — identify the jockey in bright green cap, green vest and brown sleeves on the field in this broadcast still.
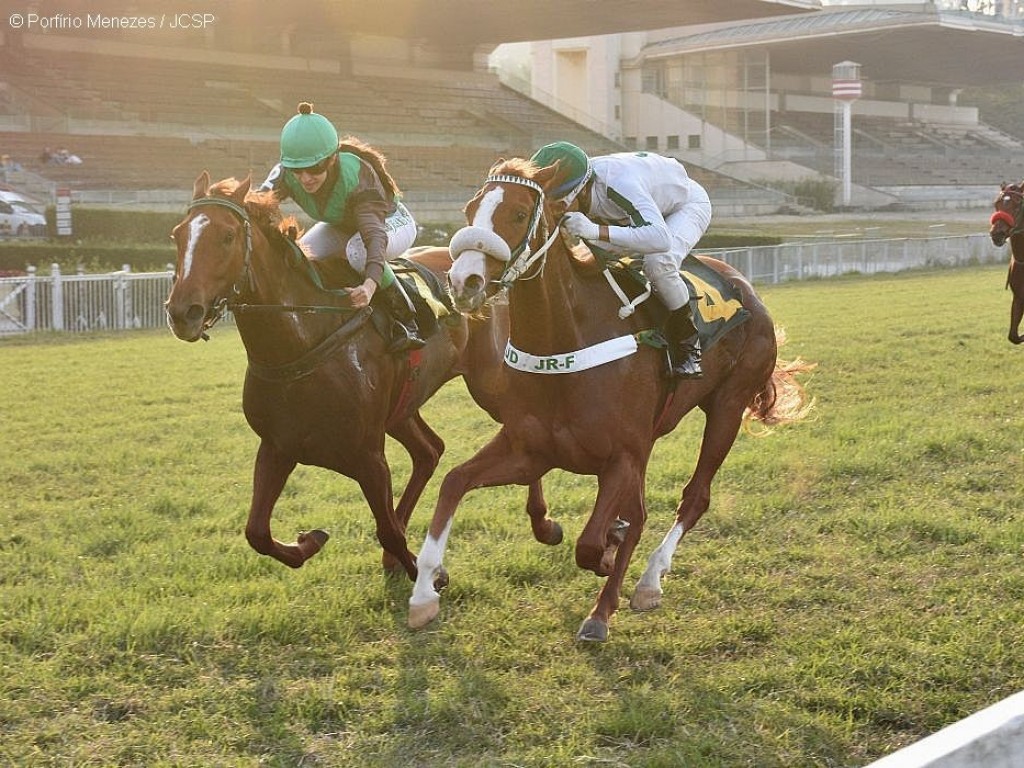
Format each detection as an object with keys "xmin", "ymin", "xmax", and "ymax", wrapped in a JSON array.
[{"xmin": 260, "ymin": 101, "xmax": 425, "ymax": 352}]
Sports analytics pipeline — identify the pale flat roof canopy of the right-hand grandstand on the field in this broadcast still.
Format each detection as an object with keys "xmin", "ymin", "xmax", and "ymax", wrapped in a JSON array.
[{"xmin": 643, "ymin": 6, "xmax": 1024, "ymax": 86}]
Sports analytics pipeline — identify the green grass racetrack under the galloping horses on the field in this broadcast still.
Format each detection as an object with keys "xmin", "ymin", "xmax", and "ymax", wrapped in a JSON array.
[{"xmin": 0, "ymin": 267, "xmax": 1024, "ymax": 768}]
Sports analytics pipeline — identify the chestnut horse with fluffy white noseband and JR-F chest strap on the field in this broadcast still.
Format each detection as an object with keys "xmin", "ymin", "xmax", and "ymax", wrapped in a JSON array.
[{"xmin": 409, "ymin": 160, "xmax": 810, "ymax": 640}]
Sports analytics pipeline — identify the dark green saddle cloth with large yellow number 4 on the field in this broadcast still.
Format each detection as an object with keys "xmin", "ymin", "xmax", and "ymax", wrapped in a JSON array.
[{"xmin": 591, "ymin": 253, "xmax": 751, "ymax": 351}]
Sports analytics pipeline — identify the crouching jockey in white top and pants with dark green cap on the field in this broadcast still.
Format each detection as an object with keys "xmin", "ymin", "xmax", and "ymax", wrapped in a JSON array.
[{"xmin": 531, "ymin": 141, "xmax": 712, "ymax": 379}]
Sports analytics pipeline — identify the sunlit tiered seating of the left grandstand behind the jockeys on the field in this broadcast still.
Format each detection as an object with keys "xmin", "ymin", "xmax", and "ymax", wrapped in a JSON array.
[{"xmin": 0, "ymin": 37, "xmax": 617, "ymax": 218}]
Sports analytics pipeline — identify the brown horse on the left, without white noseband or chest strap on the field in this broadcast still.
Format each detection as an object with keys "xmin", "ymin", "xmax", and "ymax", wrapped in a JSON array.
[{"xmin": 166, "ymin": 172, "xmax": 551, "ymax": 583}]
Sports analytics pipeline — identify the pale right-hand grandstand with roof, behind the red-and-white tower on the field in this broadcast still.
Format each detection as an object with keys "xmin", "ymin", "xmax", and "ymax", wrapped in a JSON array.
[{"xmin": 530, "ymin": 0, "xmax": 1024, "ymax": 207}]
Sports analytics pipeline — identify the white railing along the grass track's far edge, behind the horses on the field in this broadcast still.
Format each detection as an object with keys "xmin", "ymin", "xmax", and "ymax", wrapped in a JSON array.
[{"xmin": 0, "ymin": 234, "xmax": 1009, "ymax": 336}]
